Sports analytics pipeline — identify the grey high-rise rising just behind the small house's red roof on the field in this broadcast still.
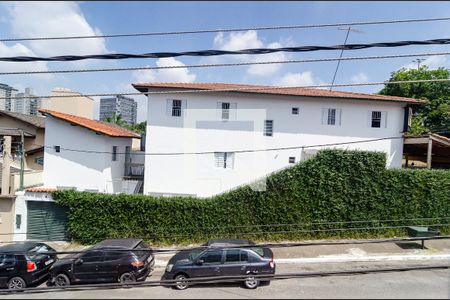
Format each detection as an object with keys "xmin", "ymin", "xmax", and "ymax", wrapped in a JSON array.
[{"xmin": 100, "ymin": 95, "xmax": 137, "ymax": 124}]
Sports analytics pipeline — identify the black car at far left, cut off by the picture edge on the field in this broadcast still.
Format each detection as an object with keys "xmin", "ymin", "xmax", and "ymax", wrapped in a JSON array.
[{"xmin": 0, "ymin": 242, "xmax": 57, "ymax": 289}]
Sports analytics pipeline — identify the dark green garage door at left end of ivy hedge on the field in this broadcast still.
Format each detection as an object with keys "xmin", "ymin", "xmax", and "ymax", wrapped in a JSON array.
[{"xmin": 27, "ymin": 201, "xmax": 68, "ymax": 241}]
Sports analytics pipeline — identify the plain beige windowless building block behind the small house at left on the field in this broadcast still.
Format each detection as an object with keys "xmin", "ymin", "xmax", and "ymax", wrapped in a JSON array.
[{"xmin": 41, "ymin": 88, "xmax": 94, "ymax": 119}]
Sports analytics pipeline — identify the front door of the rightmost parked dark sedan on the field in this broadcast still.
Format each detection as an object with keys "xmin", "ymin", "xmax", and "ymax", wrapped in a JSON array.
[{"xmin": 191, "ymin": 249, "xmax": 224, "ymax": 277}]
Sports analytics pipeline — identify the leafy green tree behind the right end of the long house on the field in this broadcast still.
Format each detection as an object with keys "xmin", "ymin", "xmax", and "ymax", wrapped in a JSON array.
[{"xmin": 379, "ymin": 66, "xmax": 450, "ymax": 136}]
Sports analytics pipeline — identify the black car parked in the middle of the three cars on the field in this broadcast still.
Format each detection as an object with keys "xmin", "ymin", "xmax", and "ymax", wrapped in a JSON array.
[{"xmin": 47, "ymin": 239, "xmax": 155, "ymax": 286}]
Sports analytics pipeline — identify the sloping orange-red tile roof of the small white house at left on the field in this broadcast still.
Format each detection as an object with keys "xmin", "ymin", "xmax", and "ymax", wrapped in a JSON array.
[{"xmin": 39, "ymin": 109, "xmax": 141, "ymax": 138}]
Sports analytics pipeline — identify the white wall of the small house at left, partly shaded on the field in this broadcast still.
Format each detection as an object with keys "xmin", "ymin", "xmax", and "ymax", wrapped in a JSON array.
[{"xmin": 44, "ymin": 117, "xmax": 131, "ymax": 193}]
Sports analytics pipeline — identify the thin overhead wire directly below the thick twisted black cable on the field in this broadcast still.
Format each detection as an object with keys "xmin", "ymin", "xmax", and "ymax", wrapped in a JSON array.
[{"xmin": 0, "ymin": 52, "xmax": 450, "ymax": 75}]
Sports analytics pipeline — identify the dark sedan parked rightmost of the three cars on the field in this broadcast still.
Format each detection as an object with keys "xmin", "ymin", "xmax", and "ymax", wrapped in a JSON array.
[{"xmin": 162, "ymin": 240, "xmax": 275, "ymax": 290}]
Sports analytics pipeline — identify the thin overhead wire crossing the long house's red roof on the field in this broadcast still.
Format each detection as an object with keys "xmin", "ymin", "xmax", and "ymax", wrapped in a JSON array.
[{"xmin": 0, "ymin": 78, "xmax": 450, "ymax": 101}]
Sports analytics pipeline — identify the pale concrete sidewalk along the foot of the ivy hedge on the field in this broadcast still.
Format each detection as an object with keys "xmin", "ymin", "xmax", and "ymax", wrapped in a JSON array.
[{"xmin": 46, "ymin": 239, "xmax": 450, "ymax": 268}]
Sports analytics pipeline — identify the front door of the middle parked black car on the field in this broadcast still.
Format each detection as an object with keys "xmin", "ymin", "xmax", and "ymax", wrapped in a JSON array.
[{"xmin": 73, "ymin": 251, "xmax": 104, "ymax": 282}]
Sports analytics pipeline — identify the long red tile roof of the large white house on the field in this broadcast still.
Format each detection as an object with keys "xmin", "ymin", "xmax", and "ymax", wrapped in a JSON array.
[{"xmin": 132, "ymin": 82, "xmax": 426, "ymax": 104}]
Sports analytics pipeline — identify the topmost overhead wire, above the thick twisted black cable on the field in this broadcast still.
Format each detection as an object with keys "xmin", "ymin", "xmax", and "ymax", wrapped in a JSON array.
[{"xmin": 0, "ymin": 17, "xmax": 450, "ymax": 42}]
